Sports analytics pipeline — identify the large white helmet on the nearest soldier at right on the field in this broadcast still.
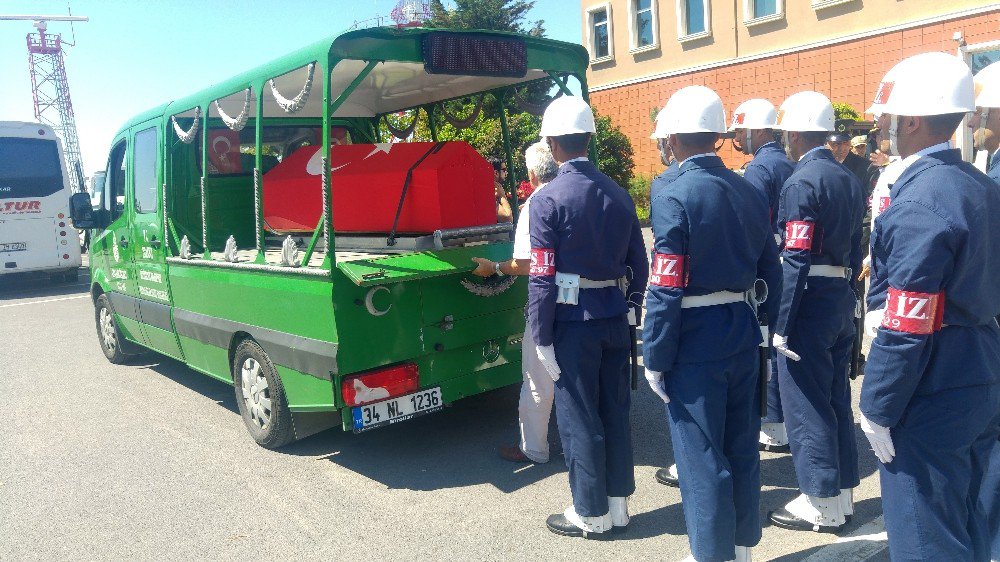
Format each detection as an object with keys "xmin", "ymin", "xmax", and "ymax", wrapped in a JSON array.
[{"xmin": 868, "ymin": 52, "xmax": 976, "ymax": 117}]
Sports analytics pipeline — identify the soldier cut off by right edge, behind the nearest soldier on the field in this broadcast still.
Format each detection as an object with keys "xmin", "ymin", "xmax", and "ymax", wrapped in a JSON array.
[{"xmin": 969, "ymin": 58, "xmax": 1000, "ymax": 560}]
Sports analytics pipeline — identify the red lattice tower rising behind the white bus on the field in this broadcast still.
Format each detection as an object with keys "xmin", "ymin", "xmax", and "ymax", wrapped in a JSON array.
[{"xmin": 0, "ymin": 14, "xmax": 90, "ymax": 187}]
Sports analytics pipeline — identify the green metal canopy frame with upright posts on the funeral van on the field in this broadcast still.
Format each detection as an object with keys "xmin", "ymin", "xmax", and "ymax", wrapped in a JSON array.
[{"xmin": 147, "ymin": 28, "xmax": 588, "ymax": 277}]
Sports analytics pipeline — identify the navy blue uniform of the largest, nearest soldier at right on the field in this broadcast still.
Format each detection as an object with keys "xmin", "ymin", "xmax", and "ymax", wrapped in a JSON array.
[{"xmin": 861, "ymin": 150, "xmax": 1000, "ymax": 560}]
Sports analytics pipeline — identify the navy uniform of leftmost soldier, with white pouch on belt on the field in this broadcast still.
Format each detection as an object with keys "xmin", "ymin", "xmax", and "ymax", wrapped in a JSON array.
[{"xmin": 528, "ymin": 160, "xmax": 649, "ymax": 517}]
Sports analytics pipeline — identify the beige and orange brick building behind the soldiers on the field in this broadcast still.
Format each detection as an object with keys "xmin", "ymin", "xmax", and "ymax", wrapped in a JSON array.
[{"xmin": 581, "ymin": 0, "xmax": 1000, "ymax": 175}]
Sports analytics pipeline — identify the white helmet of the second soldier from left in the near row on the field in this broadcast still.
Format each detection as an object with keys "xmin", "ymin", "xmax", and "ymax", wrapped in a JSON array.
[{"xmin": 652, "ymin": 86, "xmax": 726, "ymax": 139}]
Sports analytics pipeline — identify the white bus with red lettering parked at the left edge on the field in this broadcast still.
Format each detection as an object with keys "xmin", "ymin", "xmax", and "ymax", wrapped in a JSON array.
[{"xmin": 0, "ymin": 121, "xmax": 80, "ymax": 280}]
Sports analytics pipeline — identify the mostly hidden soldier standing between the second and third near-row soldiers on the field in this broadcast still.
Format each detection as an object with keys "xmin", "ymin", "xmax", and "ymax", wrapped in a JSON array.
[{"xmin": 729, "ymin": 99, "xmax": 795, "ymax": 453}]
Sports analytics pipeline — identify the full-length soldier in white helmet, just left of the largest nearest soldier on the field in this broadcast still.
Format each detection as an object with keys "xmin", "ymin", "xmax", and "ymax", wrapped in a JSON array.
[{"xmin": 769, "ymin": 92, "xmax": 864, "ymax": 532}]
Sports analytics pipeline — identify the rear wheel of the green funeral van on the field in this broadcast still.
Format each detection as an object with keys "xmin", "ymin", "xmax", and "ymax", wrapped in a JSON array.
[{"xmin": 233, "ymin": 339, "xmax": 295, "ymax": 449}]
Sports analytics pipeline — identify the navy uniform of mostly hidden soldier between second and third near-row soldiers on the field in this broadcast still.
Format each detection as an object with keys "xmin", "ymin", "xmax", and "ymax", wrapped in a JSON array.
[{"xmin": 743, "ymin": 142, "xmax": 795, "ymax": 423}]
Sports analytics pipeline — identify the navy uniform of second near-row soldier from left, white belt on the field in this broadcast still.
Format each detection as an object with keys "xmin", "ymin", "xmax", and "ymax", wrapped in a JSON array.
[{"xmin": 643, "ymin": 155, "xmax": 781, "ymax": 561}]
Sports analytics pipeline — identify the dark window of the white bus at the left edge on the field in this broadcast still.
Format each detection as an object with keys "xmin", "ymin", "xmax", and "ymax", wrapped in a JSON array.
[{"xmin": 0, "ymin": 137, "xmax": 63, "ymax": 199}]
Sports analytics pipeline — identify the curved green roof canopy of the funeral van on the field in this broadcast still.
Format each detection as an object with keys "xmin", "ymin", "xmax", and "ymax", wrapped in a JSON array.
[{"xmin": 129, "ymin": 27, "xmax": 589, "ymax": 130}]
